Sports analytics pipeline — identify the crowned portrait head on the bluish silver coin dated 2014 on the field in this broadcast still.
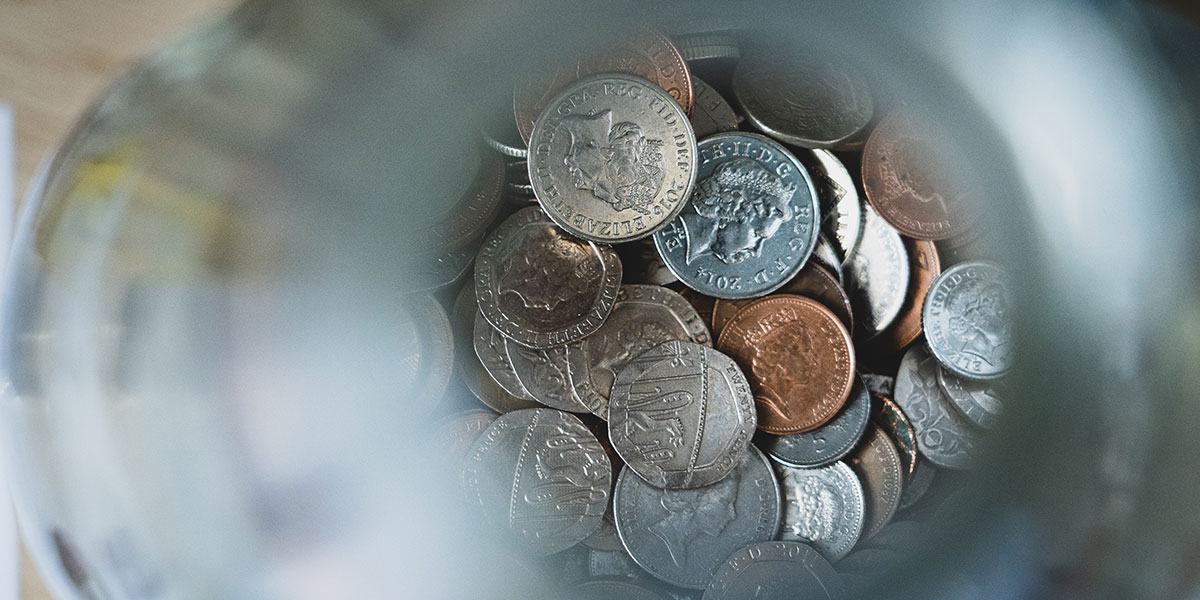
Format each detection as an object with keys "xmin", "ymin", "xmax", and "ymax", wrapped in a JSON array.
[{"xmin": 682, "ymin": 158, "xmax": 796, "ymax": 264}]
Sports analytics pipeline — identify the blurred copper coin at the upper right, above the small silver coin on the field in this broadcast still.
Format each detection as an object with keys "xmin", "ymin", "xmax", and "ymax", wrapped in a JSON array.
[{"xmin": 863, "ymin": 108, "xmax": 977, "ymax": 240}]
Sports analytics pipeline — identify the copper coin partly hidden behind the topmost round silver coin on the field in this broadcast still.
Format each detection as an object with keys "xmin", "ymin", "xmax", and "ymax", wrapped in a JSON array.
[{"xmin": 512, "ymin": 29, "xmax": 694, "ymax": 143}]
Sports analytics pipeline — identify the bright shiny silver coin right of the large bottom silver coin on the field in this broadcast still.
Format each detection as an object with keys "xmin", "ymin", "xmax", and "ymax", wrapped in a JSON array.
[{"xmin": 775, "ymin": 462, "xmax": 866, "ymax": 560}]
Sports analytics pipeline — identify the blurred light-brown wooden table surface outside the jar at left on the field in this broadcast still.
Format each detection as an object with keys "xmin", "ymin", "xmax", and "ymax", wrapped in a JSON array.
[{"xmin": 0, "ymin": 0, "xmax": 235, "ymax": 600}]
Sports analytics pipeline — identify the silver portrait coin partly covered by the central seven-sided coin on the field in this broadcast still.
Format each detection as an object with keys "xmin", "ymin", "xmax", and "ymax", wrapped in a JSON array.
[{"xmin": 566, "ymin": 284, "xmax": 713, "ymax": 419}]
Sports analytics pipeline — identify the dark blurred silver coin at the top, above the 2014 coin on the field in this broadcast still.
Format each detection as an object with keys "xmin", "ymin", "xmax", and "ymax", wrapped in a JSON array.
[{"xmin": 733, "ymin": 47, "xmax": 875, "ymax": 148}]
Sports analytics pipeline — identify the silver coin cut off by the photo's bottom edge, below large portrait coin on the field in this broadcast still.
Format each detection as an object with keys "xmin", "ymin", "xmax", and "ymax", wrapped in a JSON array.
[{"xmin": 703, "ymin": 541, "xmax": 846, "ymax": 600}]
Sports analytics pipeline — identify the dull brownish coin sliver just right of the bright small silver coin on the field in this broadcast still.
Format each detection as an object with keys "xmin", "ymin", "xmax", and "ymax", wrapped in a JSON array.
[{"xmin": 846, "ymin": 425, "xmax": 904, "ymax": 540}]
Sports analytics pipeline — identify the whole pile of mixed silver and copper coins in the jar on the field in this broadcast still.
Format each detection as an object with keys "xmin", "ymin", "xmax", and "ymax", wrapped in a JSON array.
[{"xmin": 409, "ymin": 25, "xmax": 1012, "ymax": 600}]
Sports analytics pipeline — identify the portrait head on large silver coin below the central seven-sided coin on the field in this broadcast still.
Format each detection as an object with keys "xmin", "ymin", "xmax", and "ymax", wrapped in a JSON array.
[{"xmin": 648, "ymin": 470, "xmax": 739, "ymax": 566}]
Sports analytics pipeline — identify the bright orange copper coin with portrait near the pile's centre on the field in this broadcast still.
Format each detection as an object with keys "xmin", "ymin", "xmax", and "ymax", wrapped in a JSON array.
[{"xmin": 716, "ymin": 295, "xmax": 854, "ymax": 434}]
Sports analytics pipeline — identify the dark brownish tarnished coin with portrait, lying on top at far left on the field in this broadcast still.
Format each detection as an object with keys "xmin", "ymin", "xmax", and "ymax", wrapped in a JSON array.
[{"xmin": 475, "ymin": 206, "xmax": 620, "ymax": 350}]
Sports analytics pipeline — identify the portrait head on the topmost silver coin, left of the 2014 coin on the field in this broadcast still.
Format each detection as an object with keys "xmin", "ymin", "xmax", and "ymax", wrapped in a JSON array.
[{"xmin": 562, "ymin": 110, "xmax": 666, "ymax": 215}]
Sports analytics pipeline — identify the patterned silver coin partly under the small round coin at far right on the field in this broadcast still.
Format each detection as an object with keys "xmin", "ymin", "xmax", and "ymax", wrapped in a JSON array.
[{"xmin": 894, "ymin": 344, "xmax": 979, "ymax": 469}]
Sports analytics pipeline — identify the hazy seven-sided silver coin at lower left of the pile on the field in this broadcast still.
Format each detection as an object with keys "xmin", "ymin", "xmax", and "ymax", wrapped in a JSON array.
[{"xmin": 463, "ymin": 408, "xmax": 612, "ymax": 556}]
